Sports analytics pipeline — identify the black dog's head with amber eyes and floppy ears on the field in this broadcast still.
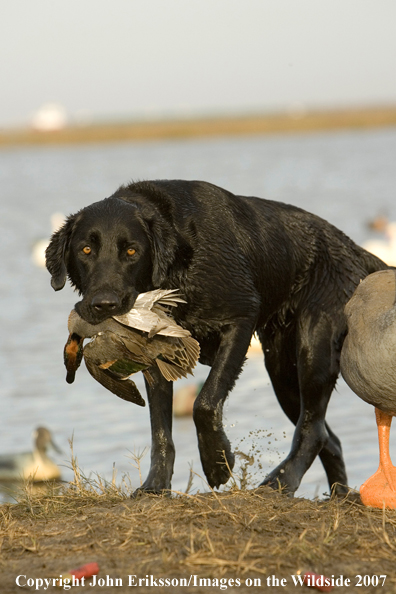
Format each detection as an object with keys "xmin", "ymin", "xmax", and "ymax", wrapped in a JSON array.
[{"xmin": 46, "ymin": 190, "xmax": 191, "ymax": 324}]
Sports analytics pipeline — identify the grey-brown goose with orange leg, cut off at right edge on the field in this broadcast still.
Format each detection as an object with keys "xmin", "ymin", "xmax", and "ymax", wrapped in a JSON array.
[{"xmin": 340, "ymin": 269, "xmax": 396, "ymax": 509}]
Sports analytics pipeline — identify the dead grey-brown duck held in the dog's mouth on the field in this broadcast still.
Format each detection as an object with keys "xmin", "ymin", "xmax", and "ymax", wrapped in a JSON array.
[{"xmin": 64, "ymin": 289, "xmax": 200, "ymax": 406}]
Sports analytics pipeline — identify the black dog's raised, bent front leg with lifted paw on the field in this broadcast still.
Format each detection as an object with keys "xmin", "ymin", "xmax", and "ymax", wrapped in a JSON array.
[{"xmin": 193, "ymin": 321, "xmax": 253, "ymax": 487}]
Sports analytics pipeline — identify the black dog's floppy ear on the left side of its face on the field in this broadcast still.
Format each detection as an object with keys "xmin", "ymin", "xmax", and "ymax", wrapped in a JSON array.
[{"xmin": 45, "ymin": 215, "xmax": 77, "ymax": 291}]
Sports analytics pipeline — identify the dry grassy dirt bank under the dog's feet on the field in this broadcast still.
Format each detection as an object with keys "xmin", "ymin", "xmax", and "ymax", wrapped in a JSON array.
[{"xmin": 0, "ymin": 474, "xmax": 396, "ymax": 594}]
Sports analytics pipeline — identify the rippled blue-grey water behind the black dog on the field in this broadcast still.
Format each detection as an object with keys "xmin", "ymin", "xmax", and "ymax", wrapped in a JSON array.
[{"xmin": 0, "ymin": 128, "xmax": 396, "ymax": 497}]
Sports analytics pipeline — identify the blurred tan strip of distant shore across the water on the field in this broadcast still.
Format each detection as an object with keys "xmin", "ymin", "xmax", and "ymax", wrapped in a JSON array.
[{"xmin": 0, "ymin": 106, "xmax": 396, "ymax": 148}]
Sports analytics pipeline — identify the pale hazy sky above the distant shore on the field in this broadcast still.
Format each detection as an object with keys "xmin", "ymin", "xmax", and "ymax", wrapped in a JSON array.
[{"xmin": 0, "ymin": 0, "xmax": 396, "ymax": 127}]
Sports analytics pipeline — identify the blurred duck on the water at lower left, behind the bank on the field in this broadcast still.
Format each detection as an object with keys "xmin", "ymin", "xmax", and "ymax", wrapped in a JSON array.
[{"xmin": 0, "ymin": 427, "xmax": 61, "ymax": 482}]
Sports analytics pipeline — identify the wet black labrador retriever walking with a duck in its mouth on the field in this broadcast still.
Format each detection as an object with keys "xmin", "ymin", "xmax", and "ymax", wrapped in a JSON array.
[{"xmin": 47, "ymin": 180, "xmax": 387, "ymax": 494}]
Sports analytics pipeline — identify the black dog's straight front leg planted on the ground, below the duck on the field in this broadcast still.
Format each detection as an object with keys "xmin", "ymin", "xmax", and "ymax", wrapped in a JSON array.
[{"xmin": 136, "ymin": 367, "xmax": 175, "ymax": 493}]
